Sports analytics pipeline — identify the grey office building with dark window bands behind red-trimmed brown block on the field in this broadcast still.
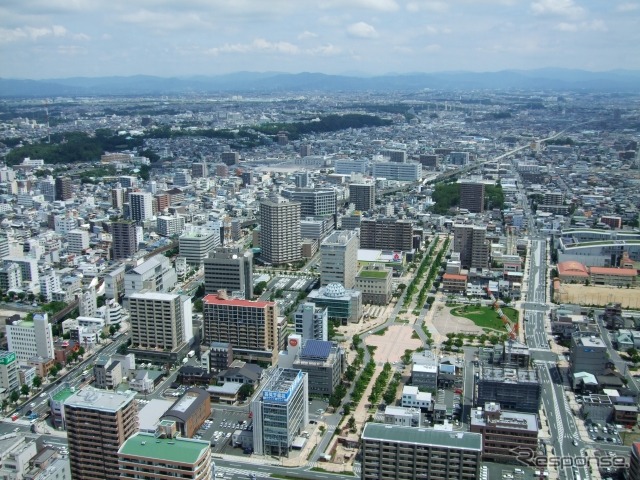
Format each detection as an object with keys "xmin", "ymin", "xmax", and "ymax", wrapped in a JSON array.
[{"xmin": 204, "ymin": 248, "xmax": 253, "ymax": 300}]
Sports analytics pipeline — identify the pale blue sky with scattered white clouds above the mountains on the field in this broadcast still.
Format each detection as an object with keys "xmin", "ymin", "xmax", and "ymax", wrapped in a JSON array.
[{"xmin": 0, "ymin": 0, "xmax": 640, "ymax": 79}]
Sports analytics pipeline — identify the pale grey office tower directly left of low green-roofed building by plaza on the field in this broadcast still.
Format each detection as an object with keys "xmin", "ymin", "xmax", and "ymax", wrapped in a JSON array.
[{"xmin": 320, "ymin": 230, "xmax": 360, "ymax": 288}]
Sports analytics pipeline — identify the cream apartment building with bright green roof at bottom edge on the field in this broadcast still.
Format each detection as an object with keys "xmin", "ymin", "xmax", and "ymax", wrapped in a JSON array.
[{"xmin": 118, "ymin": 432, "xmax": 215, "ymax": 480}]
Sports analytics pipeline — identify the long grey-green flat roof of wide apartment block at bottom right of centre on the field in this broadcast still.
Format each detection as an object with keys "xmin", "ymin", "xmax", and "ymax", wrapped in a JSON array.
[{"xmin": 362, "ymin": 422, "xmax": 482, "ymax": 452}]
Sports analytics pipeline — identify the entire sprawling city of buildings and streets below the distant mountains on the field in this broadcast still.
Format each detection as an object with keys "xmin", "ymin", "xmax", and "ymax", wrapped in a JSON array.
[{"xmin": 0, "ymin": 89, "xmax": 640, "ymax": 480}]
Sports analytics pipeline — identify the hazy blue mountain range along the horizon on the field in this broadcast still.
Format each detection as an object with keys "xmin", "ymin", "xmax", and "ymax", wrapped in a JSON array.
[{"xmin": 0, "ymin": 68, "xmax": 640, "ymax": 97}]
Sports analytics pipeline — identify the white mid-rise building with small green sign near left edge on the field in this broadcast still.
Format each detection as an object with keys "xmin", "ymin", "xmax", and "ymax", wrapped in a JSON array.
[{"xmin": 7, "ymin": 313, "xmax": 54, "ymax": 363}]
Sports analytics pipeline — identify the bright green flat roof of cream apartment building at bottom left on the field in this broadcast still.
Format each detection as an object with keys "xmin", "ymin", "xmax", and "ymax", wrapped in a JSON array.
[{"xmin": 119, "ymin": 433, "xmax": 210, "ymax": 464}]
